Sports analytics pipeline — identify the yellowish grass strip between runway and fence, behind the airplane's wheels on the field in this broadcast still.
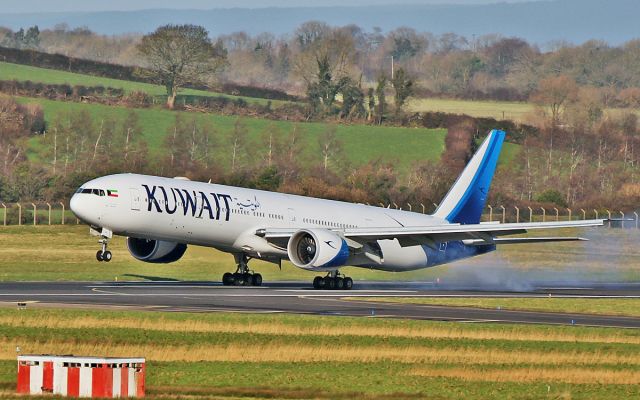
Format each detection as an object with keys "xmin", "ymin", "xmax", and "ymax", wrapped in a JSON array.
[{"xmin": 0, "ymin": 221, "xmax": 640, "ymax": 282}]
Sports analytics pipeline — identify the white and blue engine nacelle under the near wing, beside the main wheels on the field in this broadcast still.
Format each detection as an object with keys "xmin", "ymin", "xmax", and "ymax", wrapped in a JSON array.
[{"xmin": 287, "ymin": 229, "xmax": 349, "ymax": 270}]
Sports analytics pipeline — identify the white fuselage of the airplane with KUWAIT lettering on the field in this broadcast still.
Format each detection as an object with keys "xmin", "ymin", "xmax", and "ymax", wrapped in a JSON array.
[{"xmin": 71, "ymin": 174, "xmax": 488, "ymax": 271}]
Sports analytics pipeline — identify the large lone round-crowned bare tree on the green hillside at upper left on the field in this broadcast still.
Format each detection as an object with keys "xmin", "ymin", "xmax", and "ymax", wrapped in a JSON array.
[{"xmin": 138, "ymin": 25, "xmax": 226, "ymax": 108}]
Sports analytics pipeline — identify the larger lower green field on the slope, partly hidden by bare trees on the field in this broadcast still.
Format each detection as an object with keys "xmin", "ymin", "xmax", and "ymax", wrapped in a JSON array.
[{"xmin": 19, "ymin": 97, "xmax": 450, "ymax": 173}]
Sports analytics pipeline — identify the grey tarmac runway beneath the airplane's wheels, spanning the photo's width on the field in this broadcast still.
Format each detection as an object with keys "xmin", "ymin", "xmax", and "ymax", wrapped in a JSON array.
[{"xmin": 0, "ymin": 281, "xmax": 640, "ymax": 328}]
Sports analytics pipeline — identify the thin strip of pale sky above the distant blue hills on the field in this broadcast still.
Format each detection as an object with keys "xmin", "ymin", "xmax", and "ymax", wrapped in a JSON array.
[{"xmin": 0, "ymin": 0, "xmax": 530, "ymax": 14}]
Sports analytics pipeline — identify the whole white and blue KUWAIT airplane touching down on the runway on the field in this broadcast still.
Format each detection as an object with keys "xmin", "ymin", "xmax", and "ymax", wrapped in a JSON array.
[{"xmin": 70, "ymin": 130, "xmax": 604, "ymax": 290}]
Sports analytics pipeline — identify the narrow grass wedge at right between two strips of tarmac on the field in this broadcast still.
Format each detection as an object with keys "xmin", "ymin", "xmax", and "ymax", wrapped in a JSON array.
[{"xmin": 352, "ymin": 296, "xmax": 640, "ymax": 317}]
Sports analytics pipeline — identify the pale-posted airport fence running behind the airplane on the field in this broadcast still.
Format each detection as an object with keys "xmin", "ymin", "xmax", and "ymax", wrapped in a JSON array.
[{"xmin": 0, "ymin": 202, "xmax": 639, "ymax": 229}]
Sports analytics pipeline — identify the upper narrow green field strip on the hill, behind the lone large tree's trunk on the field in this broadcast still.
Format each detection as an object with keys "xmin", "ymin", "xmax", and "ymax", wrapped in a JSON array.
[{"xmin": 0, "ymin": 62, "xmax": 282, "ymax": 105}]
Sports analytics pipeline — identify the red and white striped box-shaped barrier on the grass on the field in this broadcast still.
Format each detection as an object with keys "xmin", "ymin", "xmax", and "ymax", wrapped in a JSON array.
[{"xmin": 17, "ymin": 355, "xmax": 145, "ymax": 397}]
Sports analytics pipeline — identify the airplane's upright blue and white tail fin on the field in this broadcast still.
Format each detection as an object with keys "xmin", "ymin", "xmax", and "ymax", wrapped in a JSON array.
[{"xmin": 433, "ymin": 129, "xmax": 505, "ymax": 224}]
